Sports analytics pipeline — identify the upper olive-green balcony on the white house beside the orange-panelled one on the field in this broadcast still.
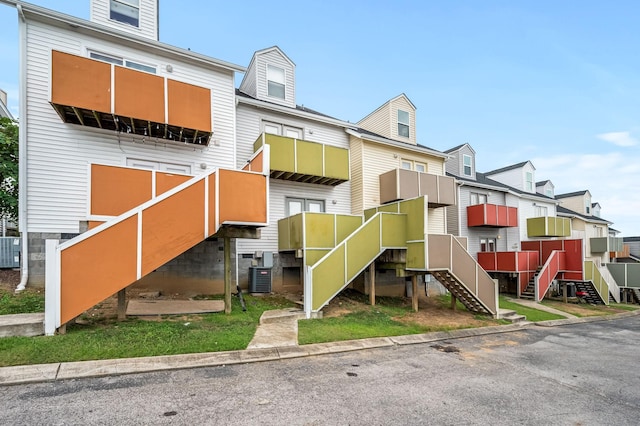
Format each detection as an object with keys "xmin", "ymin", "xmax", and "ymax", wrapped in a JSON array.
[{"xmin": 253, "ymin": 133, "xmax": 349, "ymax": 186}]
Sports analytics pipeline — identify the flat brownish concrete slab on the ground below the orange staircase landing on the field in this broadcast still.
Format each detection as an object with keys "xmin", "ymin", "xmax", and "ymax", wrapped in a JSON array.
[{"xmin": 127, "ymin": 300, "xmax": 224, "ymax": 316}]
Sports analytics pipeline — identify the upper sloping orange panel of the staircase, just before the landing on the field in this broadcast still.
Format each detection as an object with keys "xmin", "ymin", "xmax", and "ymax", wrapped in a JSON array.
[{"xmin": 142, "ymin": 180, "xmax": 205, "ymax": 276}]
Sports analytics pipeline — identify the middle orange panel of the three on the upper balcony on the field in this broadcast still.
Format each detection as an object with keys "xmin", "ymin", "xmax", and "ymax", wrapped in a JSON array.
[{"xmin": 114, "ymin": 67, "xmax": 165, "ymax": 125}]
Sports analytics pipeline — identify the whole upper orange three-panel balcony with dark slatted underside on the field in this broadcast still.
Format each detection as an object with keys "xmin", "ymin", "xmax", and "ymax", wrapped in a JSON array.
[{"xmin": 51, "ymin": 50, "xmax": 211, "ymax": 145}]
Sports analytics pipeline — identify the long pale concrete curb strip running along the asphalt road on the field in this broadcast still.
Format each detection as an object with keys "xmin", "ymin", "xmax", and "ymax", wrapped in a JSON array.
[{"xmin": 0, "ymin": 310, "xmax": 640, "ymax": 385}]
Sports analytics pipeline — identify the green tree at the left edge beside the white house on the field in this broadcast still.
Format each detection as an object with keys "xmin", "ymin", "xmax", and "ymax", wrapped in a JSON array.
[{"xmin": 0, "ymin": 117, "xmax": 18, "ymax": 220}]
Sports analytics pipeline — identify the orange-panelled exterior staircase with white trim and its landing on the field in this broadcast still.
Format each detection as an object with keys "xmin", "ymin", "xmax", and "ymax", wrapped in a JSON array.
[{"xmin": 45, "ymin": 147, "xmax": 269, "ymax": 335}]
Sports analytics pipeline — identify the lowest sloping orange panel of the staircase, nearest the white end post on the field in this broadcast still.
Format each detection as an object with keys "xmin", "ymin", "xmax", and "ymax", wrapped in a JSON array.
[{"xmin": 60, "ymin": 216, "xmax": 138, "ymax": 324}]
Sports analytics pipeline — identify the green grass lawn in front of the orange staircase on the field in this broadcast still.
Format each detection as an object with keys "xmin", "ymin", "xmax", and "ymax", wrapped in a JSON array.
[{"xmin": 0, "ymin": 295, "xmax": 293, "ymax": 366}]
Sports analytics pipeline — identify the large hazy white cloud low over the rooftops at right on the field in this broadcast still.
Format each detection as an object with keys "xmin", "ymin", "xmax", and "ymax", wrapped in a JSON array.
[{"xmin": 531, "ymin": 152, "xmax": 640, "ymax": 237}]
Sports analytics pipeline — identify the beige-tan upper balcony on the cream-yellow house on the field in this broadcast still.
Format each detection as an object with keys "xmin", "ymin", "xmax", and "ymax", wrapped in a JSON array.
[{"xmin": 380, "ymin": 169, "xmax": 456, "ymax": 207}]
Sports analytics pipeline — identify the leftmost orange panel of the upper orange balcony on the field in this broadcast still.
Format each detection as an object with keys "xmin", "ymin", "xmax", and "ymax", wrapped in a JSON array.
[{"xmin": 51, "ymin": 50, "xmax": 111, "ymax": 112}]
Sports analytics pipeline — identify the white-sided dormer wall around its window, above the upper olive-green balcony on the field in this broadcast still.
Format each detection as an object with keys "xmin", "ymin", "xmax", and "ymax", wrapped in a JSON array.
[{"xmin": 254, "ymin": 49, "xmax": 296, "ymax": 108}]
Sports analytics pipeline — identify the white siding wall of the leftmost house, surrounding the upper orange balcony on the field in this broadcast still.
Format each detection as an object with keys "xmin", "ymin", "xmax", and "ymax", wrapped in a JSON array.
[{"xmin": 26, "ymin": 23, "xmax": 235, "ymax": 233}]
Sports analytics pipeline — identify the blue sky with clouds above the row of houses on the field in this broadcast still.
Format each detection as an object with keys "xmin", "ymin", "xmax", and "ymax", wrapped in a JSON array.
[{"xmin": 0, "ymin": 0, "xmax": 640, "ymax": 236}]
